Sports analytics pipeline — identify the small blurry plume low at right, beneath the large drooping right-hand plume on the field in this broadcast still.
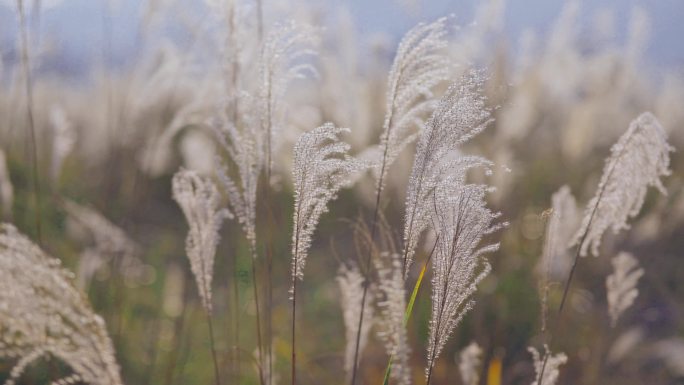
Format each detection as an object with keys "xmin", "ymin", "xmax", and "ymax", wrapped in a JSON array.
[{"xmin": 606, "ymin": 252, "xmax": 644, "ymax": 327}]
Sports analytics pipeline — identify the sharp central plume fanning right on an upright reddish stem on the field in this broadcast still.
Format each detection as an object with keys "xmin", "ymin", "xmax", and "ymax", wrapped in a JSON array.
[{"xmin": 292, "ymin": 123, "xmax": 363, "ymax": 283}]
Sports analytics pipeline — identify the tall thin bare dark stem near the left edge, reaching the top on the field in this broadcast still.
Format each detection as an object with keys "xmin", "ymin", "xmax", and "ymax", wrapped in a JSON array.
[{"xmin": 17, "ymin": 0, "xmax": 43, "ymax": 244}]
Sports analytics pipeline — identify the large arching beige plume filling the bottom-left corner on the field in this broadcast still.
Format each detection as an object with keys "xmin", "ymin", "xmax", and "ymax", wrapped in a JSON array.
[{"xmin": 0, "ymin": 223, "xmax": 122, "ymax": 385}]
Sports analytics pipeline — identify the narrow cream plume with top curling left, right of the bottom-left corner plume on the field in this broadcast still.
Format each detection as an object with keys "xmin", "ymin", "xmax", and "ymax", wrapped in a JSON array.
[{"xmin": 172, "ymin": 169, "xmax": 231, "ymax": 314}]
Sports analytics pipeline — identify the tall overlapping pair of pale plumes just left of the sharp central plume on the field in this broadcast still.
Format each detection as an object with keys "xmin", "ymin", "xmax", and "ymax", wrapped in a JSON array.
[{"xmin": 212, "ymin": 18, "xmax": 318, "ymax": 249}]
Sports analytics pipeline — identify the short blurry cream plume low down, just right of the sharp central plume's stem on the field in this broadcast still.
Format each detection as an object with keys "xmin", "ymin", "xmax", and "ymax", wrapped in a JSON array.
[{"xmin": 336, "ymin": 264, "xmax": 373, "ymax": 376}]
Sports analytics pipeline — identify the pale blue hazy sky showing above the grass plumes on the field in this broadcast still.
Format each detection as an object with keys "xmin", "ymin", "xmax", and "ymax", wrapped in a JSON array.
[{"xmin": 0, "ymin": 0, "xmax": 684, "ymax": 78}]
